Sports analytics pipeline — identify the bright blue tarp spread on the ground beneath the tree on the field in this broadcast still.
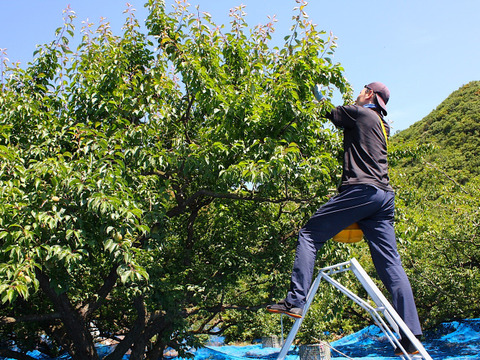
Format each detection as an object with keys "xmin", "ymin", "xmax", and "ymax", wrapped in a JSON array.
[{"xmin": 0, "ymin": 319, "xmax": 480, "ymax": 360}]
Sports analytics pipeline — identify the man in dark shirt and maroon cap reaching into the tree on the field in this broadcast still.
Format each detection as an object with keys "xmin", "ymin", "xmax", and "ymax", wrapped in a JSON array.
[{"xmin": 267, "ymin": 82, "xmax": 422, "ymax": 354}]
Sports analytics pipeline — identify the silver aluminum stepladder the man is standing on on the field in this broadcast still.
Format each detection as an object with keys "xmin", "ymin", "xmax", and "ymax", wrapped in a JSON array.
[{"xmin": 277, "ymin": 258, "xmax": 432, "ymax": 360}]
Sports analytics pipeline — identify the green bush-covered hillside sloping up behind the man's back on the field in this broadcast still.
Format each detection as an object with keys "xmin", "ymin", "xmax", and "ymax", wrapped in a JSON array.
[{"xmin": 390, "ymin": 81, "xmax": 480, "ymax": 327}]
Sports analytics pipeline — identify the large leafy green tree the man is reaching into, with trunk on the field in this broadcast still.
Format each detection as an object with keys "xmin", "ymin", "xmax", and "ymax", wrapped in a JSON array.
[{"xmin": 0, "ymin": 0, "xmax": 351, "ymax": 360}]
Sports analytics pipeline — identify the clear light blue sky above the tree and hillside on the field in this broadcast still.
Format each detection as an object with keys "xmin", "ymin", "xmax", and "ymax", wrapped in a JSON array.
[{"xmin": 0, "ymin": 0, "xmax": 480, "ymax": 132}]
